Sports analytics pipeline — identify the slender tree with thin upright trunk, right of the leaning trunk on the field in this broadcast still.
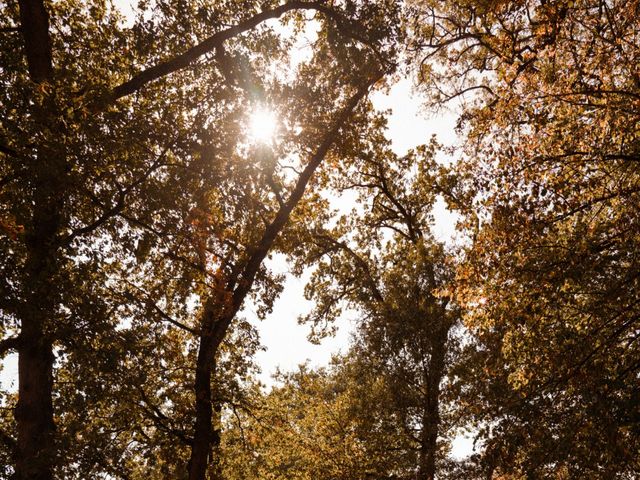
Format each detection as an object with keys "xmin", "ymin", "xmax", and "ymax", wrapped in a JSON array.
[{"xmin": 288, "ymin": 132, "xmax": 460, "ymax": 479}]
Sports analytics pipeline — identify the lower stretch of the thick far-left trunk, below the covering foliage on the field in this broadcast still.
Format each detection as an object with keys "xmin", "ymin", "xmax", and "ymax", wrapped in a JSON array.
[{"xmin": 15, "ymin": 172, "xmax": 62, "ymax": 480}]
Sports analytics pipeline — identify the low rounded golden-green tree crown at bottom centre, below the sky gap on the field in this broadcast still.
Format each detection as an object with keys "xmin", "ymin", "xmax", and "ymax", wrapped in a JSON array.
[{"xmin": 222, "ymin": 360, "xmax": 413, "ymax": 480}]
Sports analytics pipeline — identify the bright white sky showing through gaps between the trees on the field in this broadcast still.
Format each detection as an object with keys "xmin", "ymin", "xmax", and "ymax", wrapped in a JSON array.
[{"xmin": 0, "ymin": 0, "xmax": 472, "ymax": 458}]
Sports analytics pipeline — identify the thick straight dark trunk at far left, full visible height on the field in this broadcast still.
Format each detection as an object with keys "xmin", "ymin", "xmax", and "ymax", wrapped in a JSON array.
[{"xmin": 15, "ymin": 0, "xmax": 57, "ymax": 480}]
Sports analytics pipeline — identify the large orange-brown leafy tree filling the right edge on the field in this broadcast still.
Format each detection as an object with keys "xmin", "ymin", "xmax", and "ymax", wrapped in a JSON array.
[{"xmin": 414, "ymin": 0, "xmax": 640, "ymax": 478}]
